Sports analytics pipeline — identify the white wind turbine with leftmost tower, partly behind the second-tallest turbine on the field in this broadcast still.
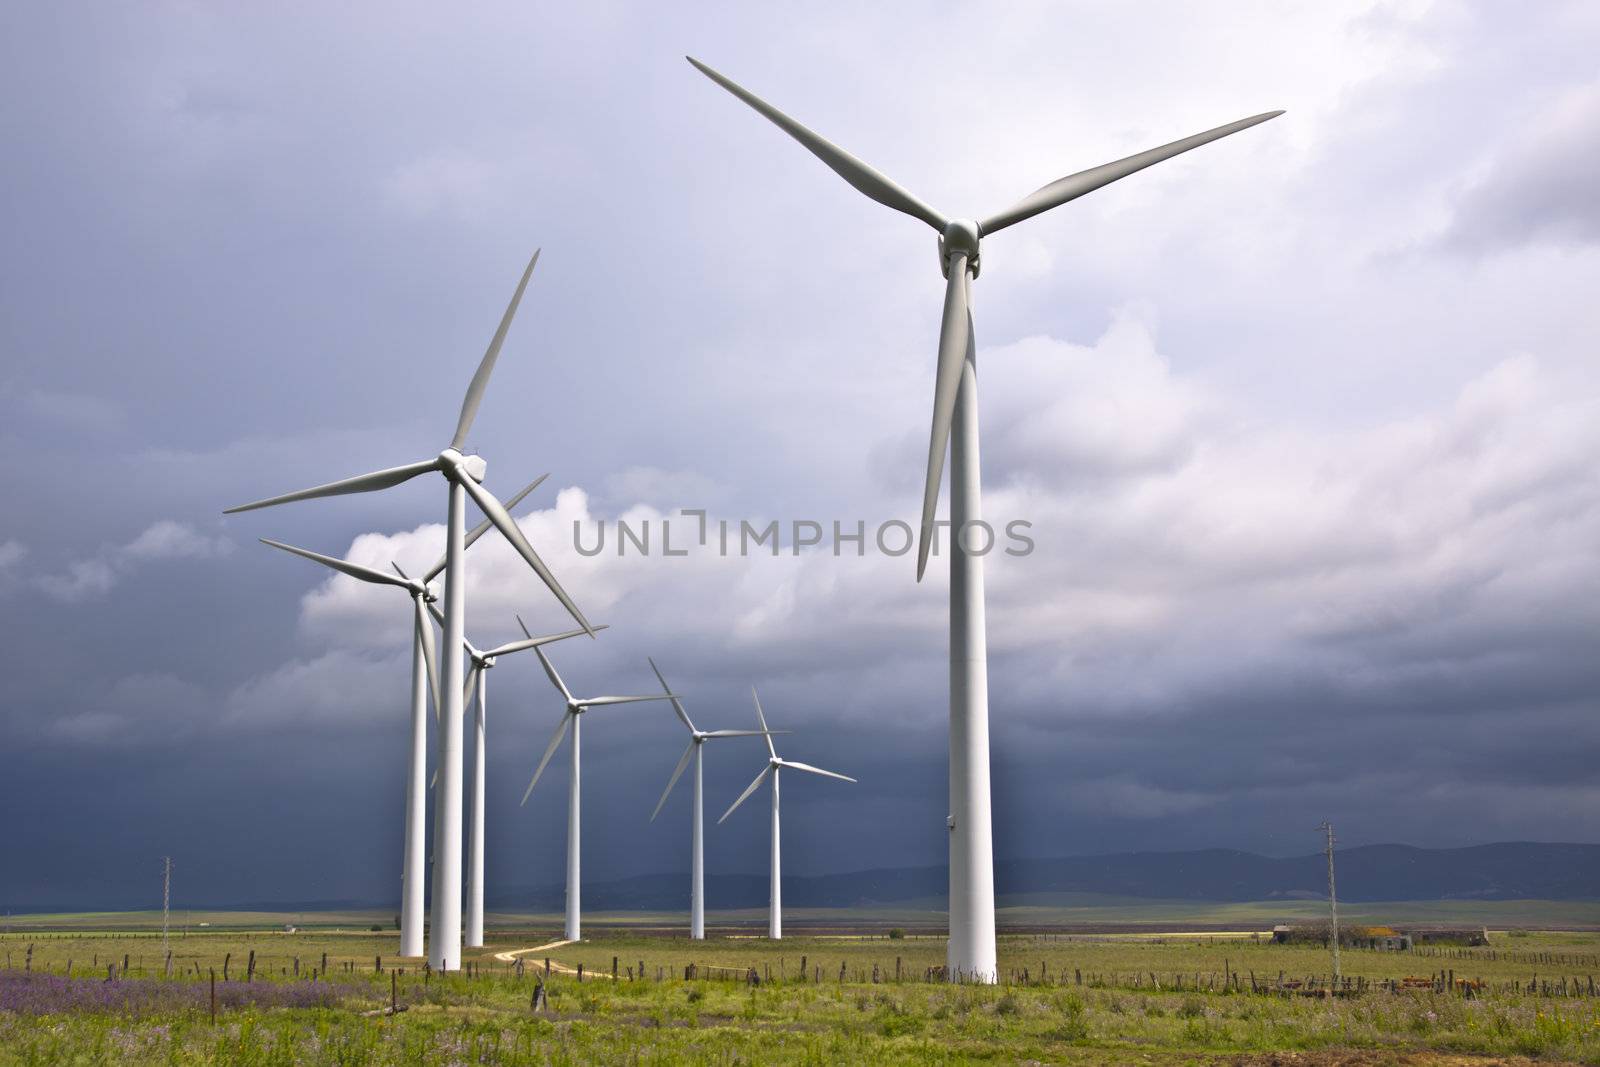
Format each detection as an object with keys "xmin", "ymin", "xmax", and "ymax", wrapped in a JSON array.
[{"xmin": 261, "ymin": 474, "xmax": 546, "ymax": 957}]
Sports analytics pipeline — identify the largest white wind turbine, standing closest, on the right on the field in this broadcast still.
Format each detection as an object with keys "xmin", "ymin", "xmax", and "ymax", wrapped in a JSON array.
[{"xmin": 686, "ymin": 56, "xmax": 1283, "ymax": 982}]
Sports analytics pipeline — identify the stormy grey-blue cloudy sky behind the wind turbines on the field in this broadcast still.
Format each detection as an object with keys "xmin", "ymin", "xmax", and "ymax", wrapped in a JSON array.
[{"xmin": 0, "ymin": 2, "xmax": 1600, "ymax": 907}]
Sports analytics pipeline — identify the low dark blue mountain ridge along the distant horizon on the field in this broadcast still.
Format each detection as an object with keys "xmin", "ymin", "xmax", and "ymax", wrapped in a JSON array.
[{"xmin": 490, "ymin": 841, "xmax": 1600, "ymax": 910}]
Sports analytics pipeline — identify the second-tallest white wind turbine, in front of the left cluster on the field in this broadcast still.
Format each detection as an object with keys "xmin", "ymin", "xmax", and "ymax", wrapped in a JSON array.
[{"xmin": 224, "ymin": 251, "xmax": 594, "ymax": 971}]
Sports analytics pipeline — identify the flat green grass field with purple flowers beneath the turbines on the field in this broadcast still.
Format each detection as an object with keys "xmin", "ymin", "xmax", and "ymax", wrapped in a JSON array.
[{"xmin": 0, "ymin": 913, "xmax": 1600, "ymax": 1064}]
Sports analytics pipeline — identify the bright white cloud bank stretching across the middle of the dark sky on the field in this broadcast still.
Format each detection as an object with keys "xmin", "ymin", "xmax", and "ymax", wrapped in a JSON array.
[{"xmin": 272, "ymin": 326, "xmax": 1600, "ymax": 758}]
